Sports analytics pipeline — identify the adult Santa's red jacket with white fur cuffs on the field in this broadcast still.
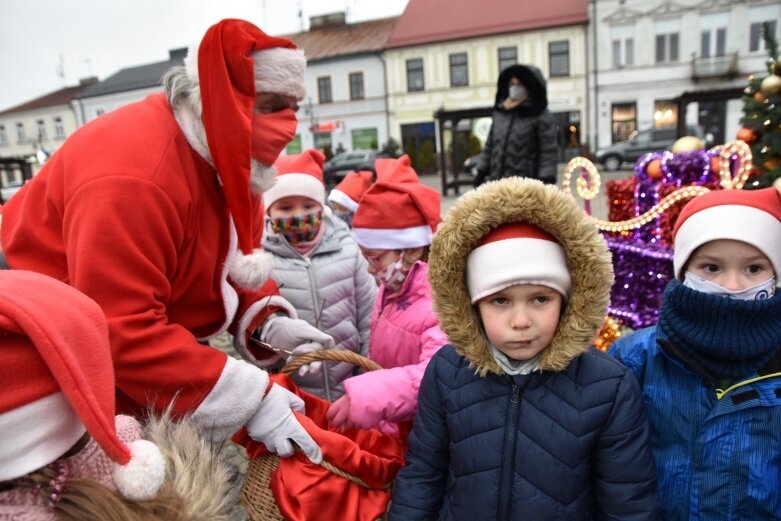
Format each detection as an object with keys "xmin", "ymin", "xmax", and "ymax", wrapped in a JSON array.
[{"xmin": 0, "ymin": 94, "xmax": 284, "ymax": 437}]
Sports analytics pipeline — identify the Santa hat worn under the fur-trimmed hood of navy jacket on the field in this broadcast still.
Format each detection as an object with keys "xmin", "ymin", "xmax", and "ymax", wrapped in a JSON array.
[{"xmin": 466, "ymin": 223, "xmax": 572, "ymax": 304}]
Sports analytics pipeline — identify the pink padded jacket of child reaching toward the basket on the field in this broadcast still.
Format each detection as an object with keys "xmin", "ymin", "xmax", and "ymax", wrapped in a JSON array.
[{"xmin": 344, "ymin": 261, "xmax": 448, "ymax": 428}]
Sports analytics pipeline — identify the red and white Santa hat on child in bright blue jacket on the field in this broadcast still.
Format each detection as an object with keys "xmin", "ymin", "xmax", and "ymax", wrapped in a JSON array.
[{"xmin": 673, "ymin": 188, "xmax": 781, "ymax": 287}]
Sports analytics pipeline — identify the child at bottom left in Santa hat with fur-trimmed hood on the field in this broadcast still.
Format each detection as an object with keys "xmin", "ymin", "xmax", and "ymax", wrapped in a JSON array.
[{"xmin": 0, "ymin": 270, "xmax": 241, "ymax": 521}]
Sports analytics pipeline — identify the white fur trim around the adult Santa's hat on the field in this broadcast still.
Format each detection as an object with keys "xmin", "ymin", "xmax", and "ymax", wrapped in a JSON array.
[{"xmin": 184, "ymin": 43, "xmax": 306, "ymax": 99}]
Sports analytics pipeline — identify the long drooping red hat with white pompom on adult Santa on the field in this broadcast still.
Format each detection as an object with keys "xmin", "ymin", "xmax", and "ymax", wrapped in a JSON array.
[{"xmin": 185, "ymin": 19, "xmax": 306, "ymax": 289}]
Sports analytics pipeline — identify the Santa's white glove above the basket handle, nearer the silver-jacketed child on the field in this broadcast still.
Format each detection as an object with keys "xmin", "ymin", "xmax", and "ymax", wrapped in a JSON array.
[{"xmin": 260, "ymin": 316, "xmax": 334, "ymax": 376}]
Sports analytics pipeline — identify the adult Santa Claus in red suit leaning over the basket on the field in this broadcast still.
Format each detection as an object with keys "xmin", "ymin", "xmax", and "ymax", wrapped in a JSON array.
[{"xmin": 0, "ymin": 20, "xmax": 333, "ymax": 461}]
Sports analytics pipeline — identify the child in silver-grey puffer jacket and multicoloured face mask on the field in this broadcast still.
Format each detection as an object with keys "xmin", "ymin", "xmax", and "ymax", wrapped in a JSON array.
[{"xmin": 253, "ymin": 149, "xmax": 377, "ymax": 401}]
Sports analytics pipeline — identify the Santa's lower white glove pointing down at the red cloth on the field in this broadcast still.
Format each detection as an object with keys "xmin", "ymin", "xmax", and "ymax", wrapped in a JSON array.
[{"xmin": 246, "ymin": 384, "xmax": 323, "ymax": 464}]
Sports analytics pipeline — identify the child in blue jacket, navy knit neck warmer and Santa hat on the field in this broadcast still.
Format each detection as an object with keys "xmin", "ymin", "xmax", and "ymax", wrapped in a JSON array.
[{"xmin": 609, "ymin": 188, "xmax": 781, "ymax": 521}]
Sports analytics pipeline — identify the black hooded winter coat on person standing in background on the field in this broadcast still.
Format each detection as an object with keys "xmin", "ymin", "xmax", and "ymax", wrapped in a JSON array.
[{"xmin": 476, "ymin": 65, "xmax": 558, "ymax": 184}]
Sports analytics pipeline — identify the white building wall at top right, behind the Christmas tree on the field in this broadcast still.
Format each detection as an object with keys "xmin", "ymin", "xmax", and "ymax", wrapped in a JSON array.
[{"xmin": 588, "ymin": 0, "xmax": 781, "ymax": 149}]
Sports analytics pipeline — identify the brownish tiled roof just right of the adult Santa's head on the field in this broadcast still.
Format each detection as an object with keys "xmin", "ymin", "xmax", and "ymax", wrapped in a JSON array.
[{"xmin": 285, "ymin": 16, "xmax": 399, "ymax": 62}]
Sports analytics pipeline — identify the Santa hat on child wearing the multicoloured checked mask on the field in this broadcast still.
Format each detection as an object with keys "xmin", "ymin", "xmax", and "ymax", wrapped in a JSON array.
[{"xmin": 263, "ymin": 148, "xmax": 325, "ymax": 211}]
